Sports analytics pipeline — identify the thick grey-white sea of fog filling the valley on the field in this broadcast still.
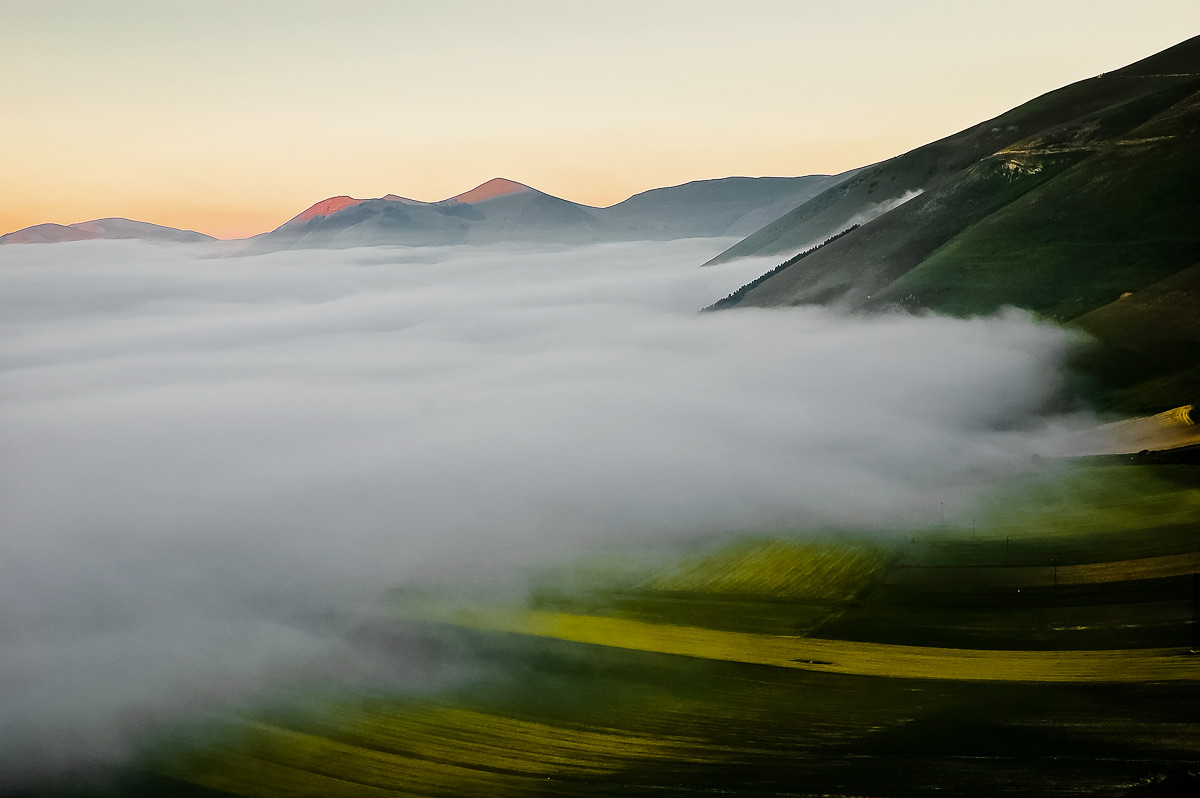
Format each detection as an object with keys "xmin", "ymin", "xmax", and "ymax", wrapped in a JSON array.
[{"xmin": 0, "ymin": 240, "xmax": 1070, "ymax": 773}]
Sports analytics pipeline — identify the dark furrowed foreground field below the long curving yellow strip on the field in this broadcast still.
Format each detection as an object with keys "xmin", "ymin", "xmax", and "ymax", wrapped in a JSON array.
[{"xmin": 136, "ymin": 644, "xmax": 1198, "ymax": 797}]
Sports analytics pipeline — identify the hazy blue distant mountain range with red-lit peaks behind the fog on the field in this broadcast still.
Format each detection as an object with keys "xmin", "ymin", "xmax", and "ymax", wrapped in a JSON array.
[{"xmin": 256, "ymin": 173, "xmax": 853, "ymax": 247}]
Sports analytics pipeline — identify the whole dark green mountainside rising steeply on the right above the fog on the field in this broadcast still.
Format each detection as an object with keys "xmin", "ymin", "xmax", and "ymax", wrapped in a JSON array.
[{"xmin": 709, "ymin": 37, "xmax": 1200, "ymax": 412}]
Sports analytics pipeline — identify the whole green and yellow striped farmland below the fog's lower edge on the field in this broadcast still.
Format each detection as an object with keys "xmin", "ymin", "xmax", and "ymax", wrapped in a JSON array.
[{"xmin": 54, "ymin": 453, "xmax": 1200, "ymax": 798}]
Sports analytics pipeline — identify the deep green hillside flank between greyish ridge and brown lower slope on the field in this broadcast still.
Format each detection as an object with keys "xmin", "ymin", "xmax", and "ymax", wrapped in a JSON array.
[{"xmin": 877, "ymin": 86, "xmax": 1200, "ymax": 322}]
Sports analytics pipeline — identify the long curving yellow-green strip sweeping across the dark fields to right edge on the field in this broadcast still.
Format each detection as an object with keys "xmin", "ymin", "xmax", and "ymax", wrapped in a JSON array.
[{"xmin": 397, "ymin": 605, "xmax": 1200, "ymax": 683}]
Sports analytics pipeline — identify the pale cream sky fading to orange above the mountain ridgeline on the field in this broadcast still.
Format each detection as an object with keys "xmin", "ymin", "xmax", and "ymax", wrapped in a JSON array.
[{"xmin": 0, "ymin": 0, "xmax": 1200, "ymax": 238}]
